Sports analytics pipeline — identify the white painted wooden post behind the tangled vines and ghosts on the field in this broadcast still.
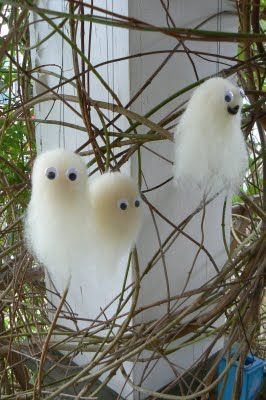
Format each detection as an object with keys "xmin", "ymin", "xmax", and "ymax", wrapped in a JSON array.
[{"xmin": 31, "ymin": 0, "xmax": 236, "ymax": 399}]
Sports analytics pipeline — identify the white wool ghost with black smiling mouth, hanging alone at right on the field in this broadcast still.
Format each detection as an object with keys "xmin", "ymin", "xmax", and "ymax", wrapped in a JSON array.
[{"xmin": 174, "ymin": 78, "xmax": 248, "ymax": 194}]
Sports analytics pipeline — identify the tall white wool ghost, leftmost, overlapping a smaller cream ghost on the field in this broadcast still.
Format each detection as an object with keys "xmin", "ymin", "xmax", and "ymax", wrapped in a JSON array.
[{"xmin": 25, "ymin": 149, "xmax": 87, "ymax": 291}]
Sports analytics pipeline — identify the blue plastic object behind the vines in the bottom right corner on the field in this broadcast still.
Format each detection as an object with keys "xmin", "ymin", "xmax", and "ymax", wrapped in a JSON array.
[{"xmin": 217, "ymin": 355, "xmax": 264, "ymax": 400}]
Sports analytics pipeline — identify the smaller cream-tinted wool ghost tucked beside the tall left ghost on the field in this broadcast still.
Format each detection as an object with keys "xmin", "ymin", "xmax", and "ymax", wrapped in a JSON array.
[{"xmin": 88, "ymin": 172, "xmax": 142, "ymax": 264}]
